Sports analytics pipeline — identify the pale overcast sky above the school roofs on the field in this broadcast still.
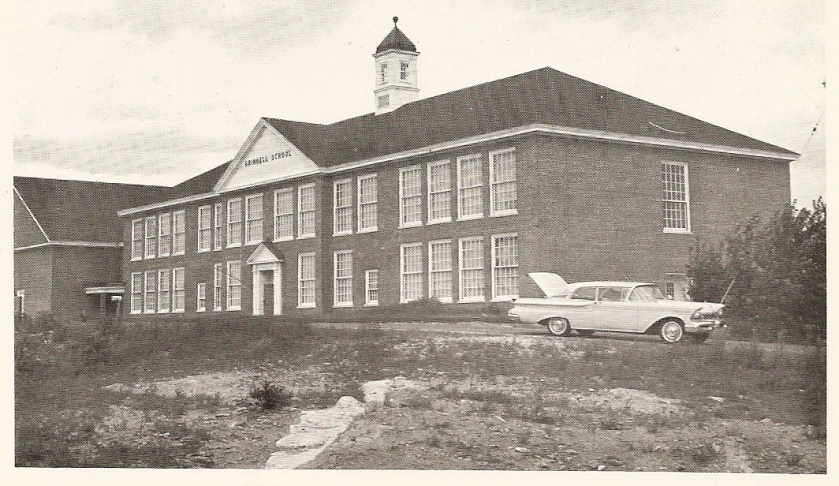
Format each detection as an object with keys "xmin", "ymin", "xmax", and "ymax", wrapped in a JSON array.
[{"xmin": 5, "ymin": 0, "xmax": 825, "ymax": 203}]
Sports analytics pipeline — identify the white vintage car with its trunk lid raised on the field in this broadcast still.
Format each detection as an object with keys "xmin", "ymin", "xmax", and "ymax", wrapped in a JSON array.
[{"xmin": 507, "ymin": 272, "xmax": 725, "ymax": 343}]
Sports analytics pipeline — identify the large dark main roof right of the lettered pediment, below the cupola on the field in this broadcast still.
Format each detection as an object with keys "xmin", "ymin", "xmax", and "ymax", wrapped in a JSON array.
[{"xmin": 265, "ymin": 67, "xmax": 797, "ymax": 167}]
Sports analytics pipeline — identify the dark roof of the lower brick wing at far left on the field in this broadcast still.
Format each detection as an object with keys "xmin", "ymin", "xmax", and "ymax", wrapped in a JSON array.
[{"xmin": 13, "ymin": 176, "xmax": 172, "ymax": 243}]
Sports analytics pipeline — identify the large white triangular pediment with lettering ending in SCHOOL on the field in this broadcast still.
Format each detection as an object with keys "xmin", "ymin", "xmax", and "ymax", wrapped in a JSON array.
[{"xmin": 215, "ymin": 120, "xmax": 320, "ymax": 193}]
